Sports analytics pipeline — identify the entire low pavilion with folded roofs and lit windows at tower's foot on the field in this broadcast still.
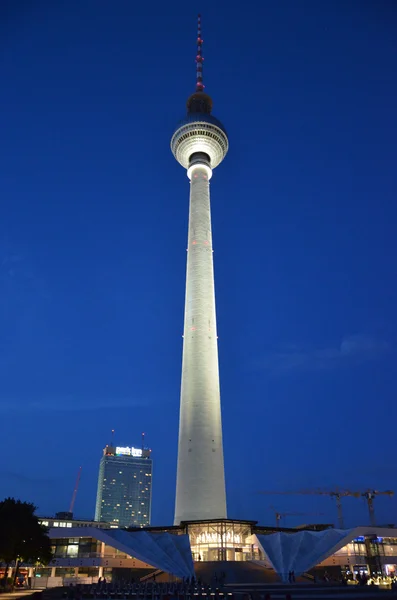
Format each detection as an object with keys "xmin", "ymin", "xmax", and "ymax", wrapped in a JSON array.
[{"xmin": 6, "ymin": 518, "xmax": 397, "ymax": 587}]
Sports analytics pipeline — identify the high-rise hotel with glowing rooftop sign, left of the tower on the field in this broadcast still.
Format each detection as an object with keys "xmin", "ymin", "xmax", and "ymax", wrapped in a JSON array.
[{"xmin": 95, "ymin": 446, "xmax": 152, "ymax": 527}]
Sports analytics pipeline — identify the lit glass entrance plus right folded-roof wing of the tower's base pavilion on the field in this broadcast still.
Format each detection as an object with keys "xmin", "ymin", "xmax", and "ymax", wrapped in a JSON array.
[{"xmin": 126, "ymin": 519, "xmax": 397, "ymax": 586}]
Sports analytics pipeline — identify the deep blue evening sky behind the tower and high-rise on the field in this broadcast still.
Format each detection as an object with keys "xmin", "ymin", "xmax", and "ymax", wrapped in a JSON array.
[{"xmin": 0, "ymin": 0, "xmax": 397, "ymax": 525}]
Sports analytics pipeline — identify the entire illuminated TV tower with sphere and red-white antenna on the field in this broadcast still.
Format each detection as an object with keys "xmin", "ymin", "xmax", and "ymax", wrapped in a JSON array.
[{"xmin": 171, "ymin": 15, "xmax": 229, "ymax": 525}]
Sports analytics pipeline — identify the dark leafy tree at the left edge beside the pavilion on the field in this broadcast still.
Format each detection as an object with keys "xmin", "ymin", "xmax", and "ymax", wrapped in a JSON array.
[{"xmin": 0, "ymin": 498, "xmax": 52, "ymax": 586}]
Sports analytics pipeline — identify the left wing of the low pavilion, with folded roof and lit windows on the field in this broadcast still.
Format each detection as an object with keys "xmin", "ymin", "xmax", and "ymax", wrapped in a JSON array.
[{"xmin": 35, "ymin": 522, "xmax": 194, "ymax": 587}]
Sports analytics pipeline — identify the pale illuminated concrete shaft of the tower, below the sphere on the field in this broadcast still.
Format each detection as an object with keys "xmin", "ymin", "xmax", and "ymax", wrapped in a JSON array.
[{"xmin": 175, "ymin": 160, "xmax": 226, "ymax": 524}]
